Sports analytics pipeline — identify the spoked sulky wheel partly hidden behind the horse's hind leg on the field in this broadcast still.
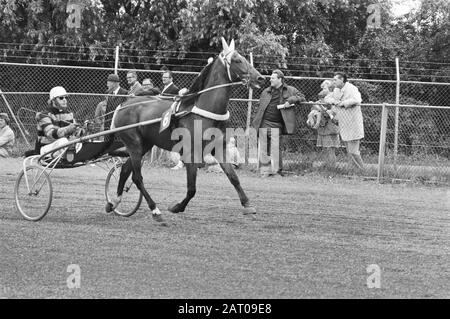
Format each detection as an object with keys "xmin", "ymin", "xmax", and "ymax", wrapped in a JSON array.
[{"xmin": 105, "ymin": 166, "xmax": 142, "ymax": 217}]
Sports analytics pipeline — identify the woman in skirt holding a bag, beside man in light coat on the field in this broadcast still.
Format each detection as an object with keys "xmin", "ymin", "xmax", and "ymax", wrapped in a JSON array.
[{"xmin": 306, "ymin": 80, "xmax": 340, "ymax": 167}]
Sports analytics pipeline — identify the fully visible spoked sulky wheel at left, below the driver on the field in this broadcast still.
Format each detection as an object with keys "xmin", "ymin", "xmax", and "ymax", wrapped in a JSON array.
[{"xmin": 14, "ymin": 165, "xmax": 53, "ymax": 221}]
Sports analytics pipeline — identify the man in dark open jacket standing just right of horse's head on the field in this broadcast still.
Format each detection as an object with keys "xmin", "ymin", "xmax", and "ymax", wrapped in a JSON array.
[{"xmin": 252, "ymin": 70, "xmax": 305, "ymax": 177}]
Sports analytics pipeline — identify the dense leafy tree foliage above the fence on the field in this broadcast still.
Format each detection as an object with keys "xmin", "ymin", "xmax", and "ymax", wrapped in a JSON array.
[{"xmin": 0, "ymin": 0, "xmax": 450, "ymax": 78}]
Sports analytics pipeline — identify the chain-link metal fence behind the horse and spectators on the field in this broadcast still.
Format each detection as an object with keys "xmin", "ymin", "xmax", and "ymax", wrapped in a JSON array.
[{"xmin": 0, "ymin": 63, "xmax": 450, "ymax": 184}]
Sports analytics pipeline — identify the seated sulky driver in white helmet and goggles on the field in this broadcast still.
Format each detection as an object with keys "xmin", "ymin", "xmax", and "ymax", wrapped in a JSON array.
[{"xmin": 36, "ymin": 86, "xmax": 78, "ymax": 157}]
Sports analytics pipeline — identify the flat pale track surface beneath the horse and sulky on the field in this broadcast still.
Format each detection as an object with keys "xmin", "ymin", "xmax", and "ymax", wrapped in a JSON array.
[{"xmin": 0, "ymin": 159, "xmax": 450, "ymax": 298}]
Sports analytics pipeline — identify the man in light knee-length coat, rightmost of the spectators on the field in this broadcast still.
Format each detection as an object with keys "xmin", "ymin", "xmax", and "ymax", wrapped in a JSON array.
[{"xmin": 333, "ymin": 72, "xmax": 364, "ymax": 170}]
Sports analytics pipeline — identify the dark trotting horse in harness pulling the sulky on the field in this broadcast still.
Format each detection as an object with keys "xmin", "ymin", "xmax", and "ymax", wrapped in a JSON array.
[{"xmin": 106, "ymin": 38, "xmax": 264, "ymax": 221}]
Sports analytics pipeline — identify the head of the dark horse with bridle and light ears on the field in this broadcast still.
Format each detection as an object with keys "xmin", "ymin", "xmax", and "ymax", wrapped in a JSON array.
[{"xmin": 219, "ymin": 38, "xmax": 264, "ymax": 88}]
